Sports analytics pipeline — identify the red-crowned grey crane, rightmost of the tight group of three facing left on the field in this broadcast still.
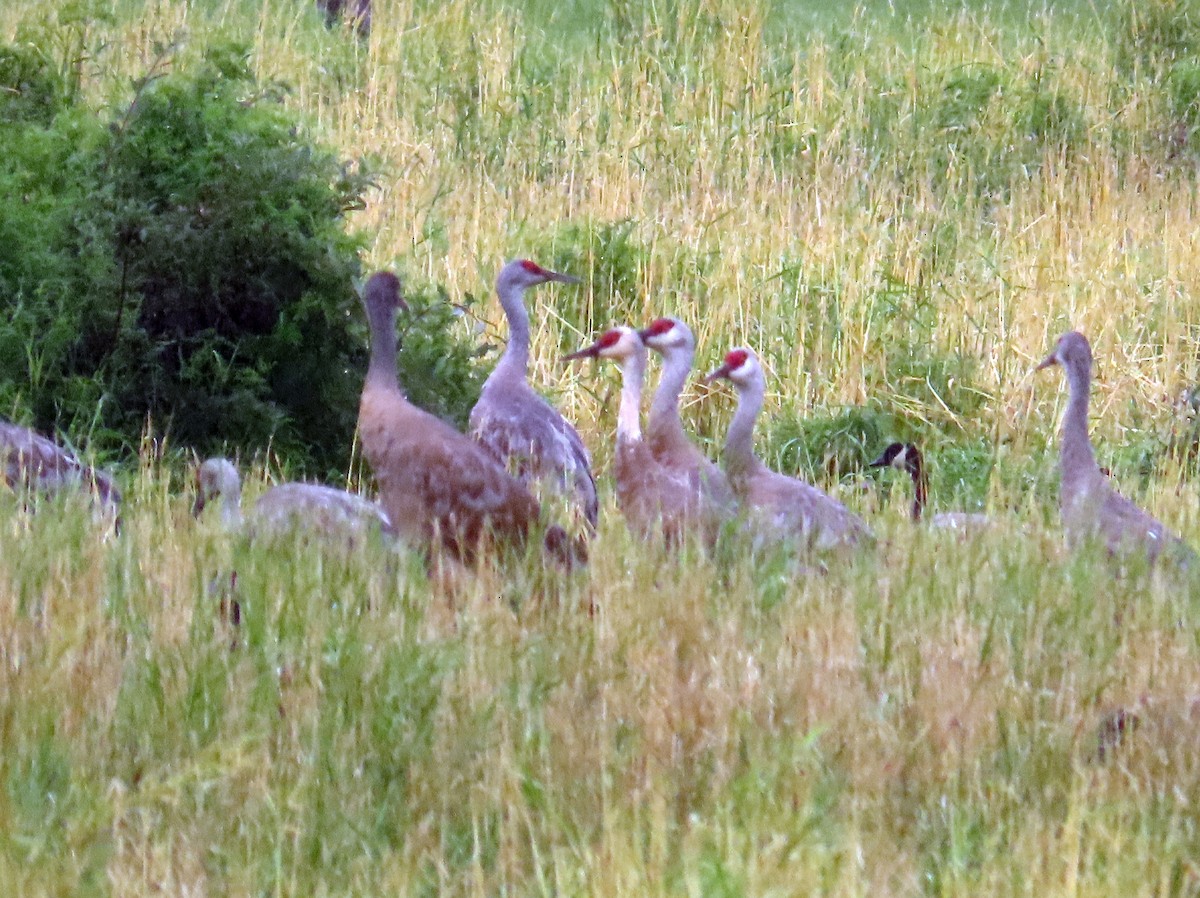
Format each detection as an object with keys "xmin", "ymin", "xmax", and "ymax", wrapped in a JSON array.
[{"xmin": 707, "ymin": 347, "xmax": 872, "ymax": 549}]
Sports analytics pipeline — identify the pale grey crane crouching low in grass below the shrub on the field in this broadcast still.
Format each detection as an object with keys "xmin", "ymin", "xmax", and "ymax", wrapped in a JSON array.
[{"xmin": 192, "ymin": 459, "xmax": 392, "ymax": 544}]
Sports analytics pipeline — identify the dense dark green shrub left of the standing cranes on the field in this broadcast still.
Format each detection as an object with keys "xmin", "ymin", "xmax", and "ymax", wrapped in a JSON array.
[{"xmin": 0, "ymin": 40, "xmax": 379, "ymax": 469}]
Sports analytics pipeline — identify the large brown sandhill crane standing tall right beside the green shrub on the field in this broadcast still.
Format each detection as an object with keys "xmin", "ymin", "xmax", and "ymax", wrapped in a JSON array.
[{"xmin": 359, "ymin": 271, "xmax": 575, "ymax": 563}]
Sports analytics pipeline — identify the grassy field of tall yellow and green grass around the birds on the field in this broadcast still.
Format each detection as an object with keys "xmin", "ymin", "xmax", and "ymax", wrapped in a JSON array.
[{"xmin": 0, "ymin": 0, "xmax": 1200, "ymax": 896}]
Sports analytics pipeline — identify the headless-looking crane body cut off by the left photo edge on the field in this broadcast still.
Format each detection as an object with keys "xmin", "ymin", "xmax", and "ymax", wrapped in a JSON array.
[{"xmin": 0, "ymin": 419, "xmax": 121, "ymax": 515}]
